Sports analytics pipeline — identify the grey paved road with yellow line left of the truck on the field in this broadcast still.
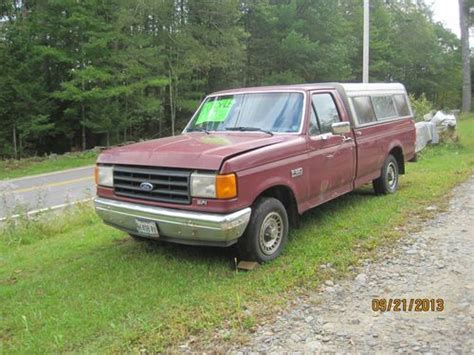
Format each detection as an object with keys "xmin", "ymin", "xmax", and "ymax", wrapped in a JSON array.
[{"xmin": 0, "ymin": 166, "xmax": 95, "ymax": 221}]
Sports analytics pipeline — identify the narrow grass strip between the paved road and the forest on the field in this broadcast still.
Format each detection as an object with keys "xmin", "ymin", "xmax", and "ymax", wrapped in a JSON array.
[{"xmin": 0, "ymin": 151, "xmax": 97, "ymax": 180}]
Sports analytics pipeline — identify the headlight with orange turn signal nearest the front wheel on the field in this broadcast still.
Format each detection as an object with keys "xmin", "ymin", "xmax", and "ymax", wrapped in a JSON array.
[{"xmin": 191, "ymin": 173, "xmax": 237, "ymax": 199}]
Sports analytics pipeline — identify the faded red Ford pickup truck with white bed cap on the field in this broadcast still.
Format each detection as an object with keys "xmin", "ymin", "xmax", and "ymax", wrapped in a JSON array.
[{"xmin": 95, "ymin": 83, "xmax": 415, "ymax": 262}]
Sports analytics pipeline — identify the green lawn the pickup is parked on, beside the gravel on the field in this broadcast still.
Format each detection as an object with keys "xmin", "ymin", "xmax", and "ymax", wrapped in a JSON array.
[{"xmin": 0, "ymin": 116, "xmax": 474, "ymax": 353}]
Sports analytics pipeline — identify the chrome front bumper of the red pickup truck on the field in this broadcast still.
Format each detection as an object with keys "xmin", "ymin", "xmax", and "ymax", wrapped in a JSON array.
[{"xmin": 94, "ymin": 197, "xmax": 252, "ymax": 246}]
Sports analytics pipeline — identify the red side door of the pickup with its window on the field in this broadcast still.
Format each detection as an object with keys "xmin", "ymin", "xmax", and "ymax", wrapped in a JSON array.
[{"xmin": 308, "ymin": 92, "xmax": 355, "ymax": 206}]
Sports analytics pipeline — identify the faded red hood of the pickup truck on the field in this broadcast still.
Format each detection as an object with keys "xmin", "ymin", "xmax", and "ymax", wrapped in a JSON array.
[{"xmin": 97, "ymin": 132, "xmax": 291, "ymax": 170}]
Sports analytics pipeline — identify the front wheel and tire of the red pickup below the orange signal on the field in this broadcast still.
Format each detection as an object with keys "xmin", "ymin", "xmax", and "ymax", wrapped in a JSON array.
[{"xmin": 237, "ymin": 197, "xmax": 289, "ymax": 263}]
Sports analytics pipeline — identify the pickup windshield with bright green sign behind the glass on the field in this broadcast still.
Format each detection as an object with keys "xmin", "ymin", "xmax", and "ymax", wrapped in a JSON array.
[{"xmin": 187, "ymin": 92, "xmax": 303, "ymax": 132}]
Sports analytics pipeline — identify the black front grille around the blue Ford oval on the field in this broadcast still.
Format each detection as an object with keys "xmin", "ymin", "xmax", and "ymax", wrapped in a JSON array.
[{"xmin": 114, "ymin": 165, "xmax": 191, "ymax": 204}]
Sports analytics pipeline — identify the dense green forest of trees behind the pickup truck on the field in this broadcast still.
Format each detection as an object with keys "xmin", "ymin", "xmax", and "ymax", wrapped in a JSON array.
[{"xmin": 0, "ymin": 0, "xmax": 462, "ymax": 158}]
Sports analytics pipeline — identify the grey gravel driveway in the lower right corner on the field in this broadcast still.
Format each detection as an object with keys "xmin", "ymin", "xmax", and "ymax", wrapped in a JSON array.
[{"xmin": 227, "ymin": 178, "xmax": 474, "ymax": 354}]
